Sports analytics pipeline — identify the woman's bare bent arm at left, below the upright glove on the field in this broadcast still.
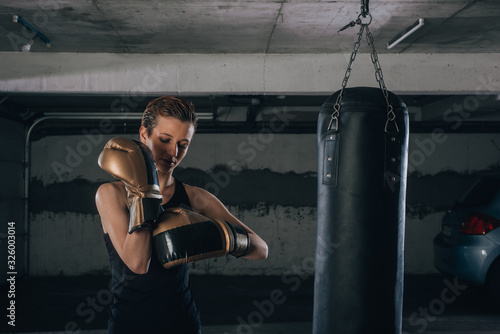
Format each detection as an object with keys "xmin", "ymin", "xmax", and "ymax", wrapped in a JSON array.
[{"xmin": 95, "ymin": 182, "xmax": 151, "ymax": 274}]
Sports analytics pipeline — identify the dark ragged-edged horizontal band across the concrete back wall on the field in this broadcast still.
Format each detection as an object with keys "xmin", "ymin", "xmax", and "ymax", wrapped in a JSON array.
[{"xmin": 30, "ymin": 165, "xmax": 500, "ymax": 219}]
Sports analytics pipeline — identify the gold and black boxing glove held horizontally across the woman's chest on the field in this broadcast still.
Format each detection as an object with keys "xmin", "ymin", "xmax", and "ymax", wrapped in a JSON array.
[{"xmin": 153, "ymin": 208, "xmax": 250, "ymax": 269}]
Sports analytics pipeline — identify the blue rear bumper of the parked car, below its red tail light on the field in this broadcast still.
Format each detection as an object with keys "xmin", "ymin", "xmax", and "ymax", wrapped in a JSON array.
[{"xmin": 434, "ymin": 233, "xmax": 498, "ymax": 285}]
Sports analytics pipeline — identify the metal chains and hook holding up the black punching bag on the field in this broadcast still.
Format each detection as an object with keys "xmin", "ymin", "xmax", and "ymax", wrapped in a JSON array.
[{"xmin": 328, "ymin": 7, "xmax": 399, "ymax": 132}]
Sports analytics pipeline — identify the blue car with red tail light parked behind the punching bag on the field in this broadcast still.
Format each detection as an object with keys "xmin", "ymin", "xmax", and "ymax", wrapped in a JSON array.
[{"xmin": 434, "ymin": 175, "xmax": 500, "ymax": 298}]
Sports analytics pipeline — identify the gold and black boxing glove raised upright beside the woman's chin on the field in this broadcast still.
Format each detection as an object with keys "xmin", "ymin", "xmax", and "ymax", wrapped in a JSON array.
[{"xmin": 98, "ymin": 137, "xmax": 163, "ymax": 233}]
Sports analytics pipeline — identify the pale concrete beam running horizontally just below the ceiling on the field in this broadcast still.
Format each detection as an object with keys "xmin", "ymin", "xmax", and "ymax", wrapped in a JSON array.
[{"xmin": 0, "ymin": 52, "xmax": 500, "ymax": 95}]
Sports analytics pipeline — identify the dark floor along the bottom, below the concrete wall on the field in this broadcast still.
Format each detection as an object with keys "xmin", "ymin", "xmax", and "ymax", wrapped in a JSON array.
[{"xmin": 0, "ymin": 275, "xmax": 500, "ymax": 333}]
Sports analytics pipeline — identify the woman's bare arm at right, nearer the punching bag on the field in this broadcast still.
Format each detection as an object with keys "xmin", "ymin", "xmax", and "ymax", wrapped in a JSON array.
[{"xmin": 185, "ymin": 185, "xmax": 268, "ymax": 260}]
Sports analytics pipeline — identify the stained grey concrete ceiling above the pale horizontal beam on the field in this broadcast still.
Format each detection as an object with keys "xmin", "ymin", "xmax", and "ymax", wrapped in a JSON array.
[{"xmin": 0, "ymin": 0, "xmax": 500, "ymax": 54}]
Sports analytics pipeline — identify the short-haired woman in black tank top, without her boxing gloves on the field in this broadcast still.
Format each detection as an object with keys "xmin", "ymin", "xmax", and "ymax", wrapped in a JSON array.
[{"xmin": 96, "ymin": 96, "xmax": 267, "ymax": 334}]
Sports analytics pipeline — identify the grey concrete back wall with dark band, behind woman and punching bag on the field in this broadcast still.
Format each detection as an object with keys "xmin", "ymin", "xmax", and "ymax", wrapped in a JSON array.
[{"xmin": 30, "ymin": 129, "xmax": 500, "ymax": 275}]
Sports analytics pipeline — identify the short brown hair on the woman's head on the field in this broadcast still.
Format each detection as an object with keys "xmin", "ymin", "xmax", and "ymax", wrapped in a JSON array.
[{"xmin": 141, "ymin": 95, "xmax": 198, "ymax": 136}]
